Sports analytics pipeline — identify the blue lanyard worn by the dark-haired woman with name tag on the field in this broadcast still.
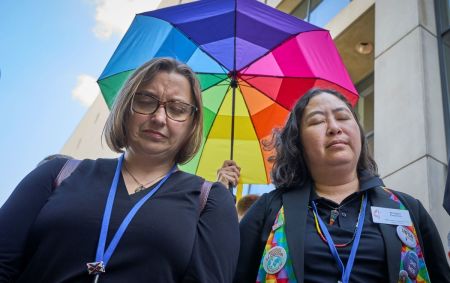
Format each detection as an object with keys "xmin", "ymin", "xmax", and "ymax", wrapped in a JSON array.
[{"xmin": 311, "ymin": 193, "xmax": 367, "ymax": 283}]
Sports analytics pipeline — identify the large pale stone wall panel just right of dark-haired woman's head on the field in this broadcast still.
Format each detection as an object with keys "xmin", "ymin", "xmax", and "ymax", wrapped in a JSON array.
[{"xmin": 374, "ymin": 28, "xmax": 427, "ymax": 177}]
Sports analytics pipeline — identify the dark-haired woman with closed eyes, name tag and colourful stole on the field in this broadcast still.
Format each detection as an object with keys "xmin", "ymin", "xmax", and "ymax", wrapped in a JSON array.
[{"xmin": 235, "ymin": 89, "xmax": 450, "ymax": 283}]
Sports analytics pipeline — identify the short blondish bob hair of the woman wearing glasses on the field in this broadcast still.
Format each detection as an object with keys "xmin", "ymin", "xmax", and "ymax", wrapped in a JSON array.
[{"xmin": 103, "ymin": 58, "xmax": 203, "ymax": 164}]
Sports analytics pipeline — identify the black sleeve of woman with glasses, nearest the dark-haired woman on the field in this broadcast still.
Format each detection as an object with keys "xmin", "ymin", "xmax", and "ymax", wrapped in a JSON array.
[{"xmin": 183, "ymin": 183, "xmax": 239, "ymax": 283}]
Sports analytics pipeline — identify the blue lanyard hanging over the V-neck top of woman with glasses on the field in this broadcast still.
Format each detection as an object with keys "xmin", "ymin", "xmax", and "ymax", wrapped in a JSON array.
[{"xmin": 95, "ymin": 154, "xmax": 177, "ymax": 266}]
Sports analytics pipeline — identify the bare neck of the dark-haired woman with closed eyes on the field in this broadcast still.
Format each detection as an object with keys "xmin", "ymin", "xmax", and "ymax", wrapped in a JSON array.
[{"xmin": 313, "ymin": 172, "xmax": 359, "ymax": 204}]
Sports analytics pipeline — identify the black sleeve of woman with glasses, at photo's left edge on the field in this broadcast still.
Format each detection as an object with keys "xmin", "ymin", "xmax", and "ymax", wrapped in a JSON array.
[{"xmin": 0, "ymin": 159, "xmax": 67, "ymax": 282}]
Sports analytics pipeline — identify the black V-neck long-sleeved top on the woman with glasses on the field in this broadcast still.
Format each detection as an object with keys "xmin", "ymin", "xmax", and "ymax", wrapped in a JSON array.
[{"xmin": 0, "ymin": 159, "xmax": 239, "ymax": 283}]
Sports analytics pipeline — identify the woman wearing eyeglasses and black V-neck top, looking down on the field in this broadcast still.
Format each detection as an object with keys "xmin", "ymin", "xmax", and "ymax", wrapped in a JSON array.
[{"xmin": 0, "ymin": 58, "xmax": 239, "ymax": 283}]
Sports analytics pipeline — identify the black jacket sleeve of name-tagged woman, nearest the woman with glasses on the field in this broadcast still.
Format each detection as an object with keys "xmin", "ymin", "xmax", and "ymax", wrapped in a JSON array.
[{"xmin": 234, "ymin": 194, "xmax": 268, "ymax": 283}]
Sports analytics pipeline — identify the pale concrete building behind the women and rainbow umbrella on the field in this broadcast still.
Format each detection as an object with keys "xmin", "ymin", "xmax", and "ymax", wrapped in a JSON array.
[{"xmin": 61, "ymin": 0, "xmax": 450, "ymax": 255}]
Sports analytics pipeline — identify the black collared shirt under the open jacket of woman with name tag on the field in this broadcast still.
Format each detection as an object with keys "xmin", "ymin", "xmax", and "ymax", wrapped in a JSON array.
[{"xmin": 305, "ymin": 181, "xmax": 387, "ymax": 283}]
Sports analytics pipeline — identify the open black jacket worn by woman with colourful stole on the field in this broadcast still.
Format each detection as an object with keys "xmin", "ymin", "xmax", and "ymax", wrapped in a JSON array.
[{"xmin": 234, "ymin": 178, "xmax": 450, "ymax": 283}]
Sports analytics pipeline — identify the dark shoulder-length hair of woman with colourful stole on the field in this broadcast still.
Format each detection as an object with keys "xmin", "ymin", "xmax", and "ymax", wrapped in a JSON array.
[{"xmin": 271, "ymin": 88, "xmax": 378, "ymax": 189}]
